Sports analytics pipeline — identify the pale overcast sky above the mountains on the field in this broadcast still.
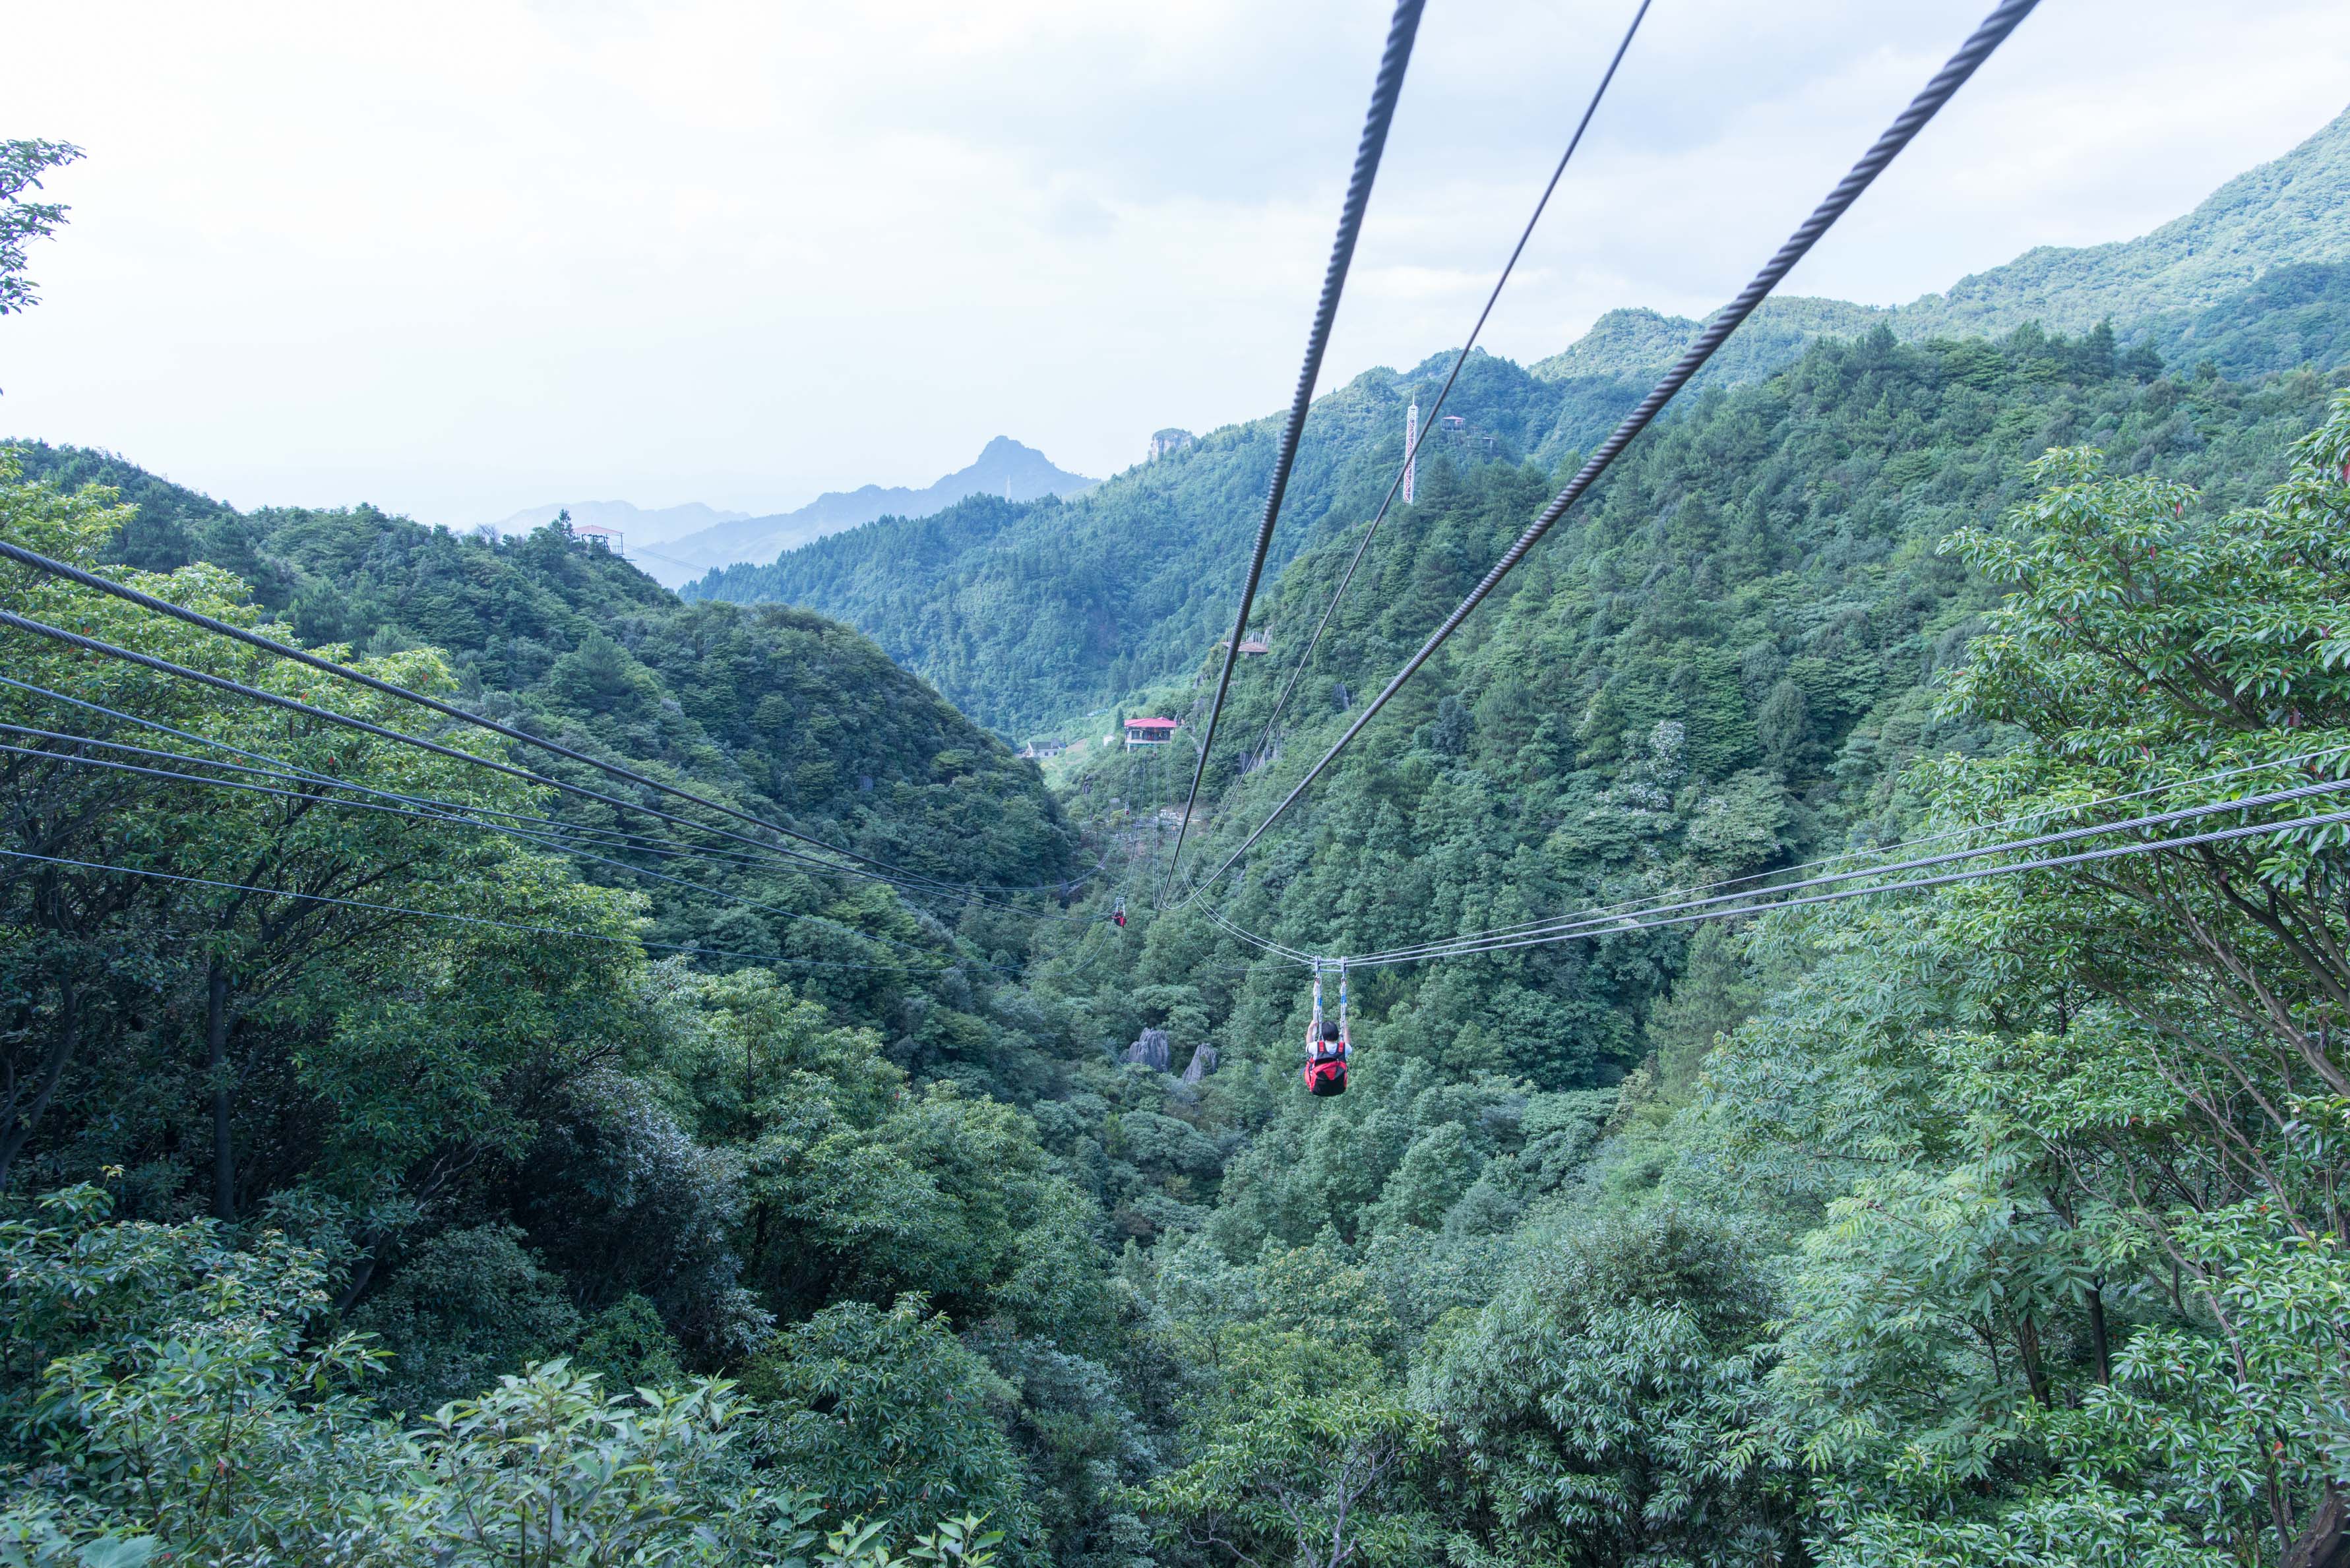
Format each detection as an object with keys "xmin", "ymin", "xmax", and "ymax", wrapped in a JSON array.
[{"xmin": 0, "ymin": 0, "xmax": 2350, "ymax": 524}]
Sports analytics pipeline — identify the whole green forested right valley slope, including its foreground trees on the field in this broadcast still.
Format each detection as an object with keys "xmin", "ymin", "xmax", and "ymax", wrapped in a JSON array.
[{"xmin": 1015, "ymin": 350, "xmax": 2350, "ymax": 1568}]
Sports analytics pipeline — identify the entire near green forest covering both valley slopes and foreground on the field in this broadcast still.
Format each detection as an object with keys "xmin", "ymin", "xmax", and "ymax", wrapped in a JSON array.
[{"xmin": 0, "ymin": 346, "xmax": 2350, "ymax": 1568}]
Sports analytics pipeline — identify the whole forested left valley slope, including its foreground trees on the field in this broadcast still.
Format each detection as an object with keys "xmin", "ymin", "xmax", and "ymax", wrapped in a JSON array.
[{"xmin": 0, "ymin": 446, "xmax": 1175, "ymax": 1565}]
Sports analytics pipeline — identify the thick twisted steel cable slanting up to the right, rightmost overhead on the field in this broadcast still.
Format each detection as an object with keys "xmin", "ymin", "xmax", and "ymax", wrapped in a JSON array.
[{"xmin": 1177, "ymin": 0, "xmax": 2040, "ymax": 907}]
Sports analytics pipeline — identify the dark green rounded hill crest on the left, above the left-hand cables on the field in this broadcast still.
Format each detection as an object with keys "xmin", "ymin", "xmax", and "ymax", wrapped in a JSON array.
[{"xmin": 14, "ymin": 442, "xmax": 1074, "ymax": 907}]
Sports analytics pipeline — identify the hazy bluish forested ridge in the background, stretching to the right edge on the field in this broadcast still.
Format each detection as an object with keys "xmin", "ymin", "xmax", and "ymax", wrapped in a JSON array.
[{"xmin": 684, "ymin": 101, "xmax": 2350, "ymax": 731}]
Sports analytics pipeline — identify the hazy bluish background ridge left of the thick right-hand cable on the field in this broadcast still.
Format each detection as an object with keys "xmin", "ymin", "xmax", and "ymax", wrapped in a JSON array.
[{"xmin": 686, "ymin": 353, "xmax": 1645, "ymax": 731}]
